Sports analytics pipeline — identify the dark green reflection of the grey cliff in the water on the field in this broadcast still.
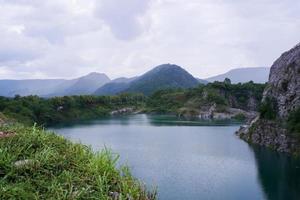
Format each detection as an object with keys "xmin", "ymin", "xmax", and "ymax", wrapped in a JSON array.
[{"xmin": 253, "ymin": 146, "xmax": 300, "ymax": 200}]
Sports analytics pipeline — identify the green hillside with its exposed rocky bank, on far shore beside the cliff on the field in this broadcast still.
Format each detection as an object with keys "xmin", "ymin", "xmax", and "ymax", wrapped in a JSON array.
[{"xmin": 146, "ymin": 79, "xmax": 265, "ymax": 120}]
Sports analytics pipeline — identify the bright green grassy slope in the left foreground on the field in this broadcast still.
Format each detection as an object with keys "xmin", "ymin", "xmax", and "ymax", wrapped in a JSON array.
[{"xmin": 0, "ymin": 125, "xmax": 156, "ymax": 200}]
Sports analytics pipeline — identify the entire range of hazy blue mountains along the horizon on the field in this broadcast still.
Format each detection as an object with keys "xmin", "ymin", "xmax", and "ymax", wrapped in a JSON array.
[{"xmin": 0, "ymin": 64, "xmax": 269, "ymax": 97}]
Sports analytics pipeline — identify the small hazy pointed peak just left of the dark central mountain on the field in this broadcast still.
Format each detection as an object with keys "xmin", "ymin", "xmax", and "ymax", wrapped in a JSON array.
[{"xmin": 55, "ymin": 72, "xmax": 110, "ymax": 95}]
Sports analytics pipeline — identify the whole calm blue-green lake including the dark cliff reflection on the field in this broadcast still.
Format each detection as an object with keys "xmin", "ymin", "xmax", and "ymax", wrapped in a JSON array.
[{"xmin": 52, "ymin": 115, "xmax": 300, "ymax": 200}]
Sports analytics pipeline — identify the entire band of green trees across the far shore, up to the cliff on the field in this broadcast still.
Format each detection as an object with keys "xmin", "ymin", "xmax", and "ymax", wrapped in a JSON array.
[{"xmin": 0, "ymin": 79, "xmax": 266, "ymax": 126}]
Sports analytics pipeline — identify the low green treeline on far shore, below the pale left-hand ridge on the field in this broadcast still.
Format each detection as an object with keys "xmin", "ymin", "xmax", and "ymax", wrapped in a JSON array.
[{"xmin": 0, "ymin": 94, "xmax": 145, "ymax": 126}]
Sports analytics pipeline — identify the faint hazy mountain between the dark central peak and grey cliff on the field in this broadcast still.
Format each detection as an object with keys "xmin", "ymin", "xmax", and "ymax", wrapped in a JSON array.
[{"xmin": 206, "ymin": 67, "xmax": 270, "ymax": 83}]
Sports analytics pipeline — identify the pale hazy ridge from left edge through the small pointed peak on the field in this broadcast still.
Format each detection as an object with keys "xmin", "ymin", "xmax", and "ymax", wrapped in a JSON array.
[{"xmin": 0, "ymin": 72, "xmax": 110, "ymax": 97}]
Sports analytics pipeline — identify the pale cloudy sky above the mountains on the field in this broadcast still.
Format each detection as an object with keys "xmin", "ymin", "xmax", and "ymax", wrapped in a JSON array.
[{"xmin": 0, "ymin": 0, "xmax": 300, "ymax": 79}]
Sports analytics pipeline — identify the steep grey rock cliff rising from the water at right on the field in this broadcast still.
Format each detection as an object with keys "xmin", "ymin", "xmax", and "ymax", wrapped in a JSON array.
[{"xmin": 237, "ymin": 44, "xmax": 300, "ymax": 153}]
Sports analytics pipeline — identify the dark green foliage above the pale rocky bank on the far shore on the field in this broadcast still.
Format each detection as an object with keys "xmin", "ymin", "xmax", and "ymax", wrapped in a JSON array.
[{"xmin": 147, "ymin": 79, "xmax": 265, "ymax": 112}]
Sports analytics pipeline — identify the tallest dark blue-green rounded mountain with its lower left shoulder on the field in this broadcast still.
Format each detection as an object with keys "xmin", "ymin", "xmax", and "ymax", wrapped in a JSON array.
[{"xmin": 95, "ymin": 64, "xmax": 199, "ymax": 95}]
